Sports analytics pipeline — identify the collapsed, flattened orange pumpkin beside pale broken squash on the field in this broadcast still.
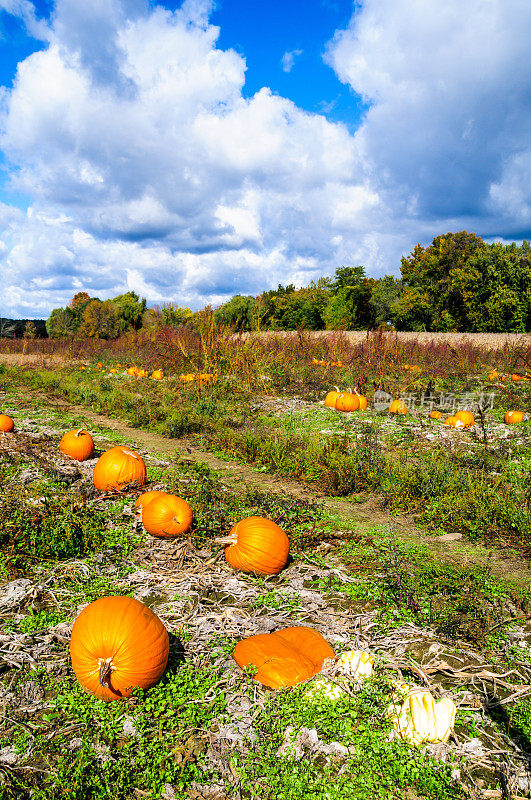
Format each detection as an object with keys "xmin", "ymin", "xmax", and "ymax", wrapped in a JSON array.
[{"xmin": 232, "ymin": 627, "xmax": 335, "ymax": 689}]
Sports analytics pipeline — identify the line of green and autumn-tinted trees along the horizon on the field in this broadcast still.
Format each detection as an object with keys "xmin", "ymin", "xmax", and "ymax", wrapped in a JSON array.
[{"xmin": 40, "ymin": 231, "xmax": 531, "ymax": 339}]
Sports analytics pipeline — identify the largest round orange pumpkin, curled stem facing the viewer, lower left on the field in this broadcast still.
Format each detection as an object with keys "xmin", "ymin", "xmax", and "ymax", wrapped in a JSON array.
[{"xmin": 70, "ymin": 597, "xmax": 169, "ymax": 700}]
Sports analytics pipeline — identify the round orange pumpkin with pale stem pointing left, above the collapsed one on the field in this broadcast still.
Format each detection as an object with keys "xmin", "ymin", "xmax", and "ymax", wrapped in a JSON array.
[{"xmin": 216, "ymin": 517, "xmax": 289, "ymax": 575}]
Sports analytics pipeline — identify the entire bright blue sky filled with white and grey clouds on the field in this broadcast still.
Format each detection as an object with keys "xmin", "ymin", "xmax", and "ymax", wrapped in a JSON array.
[{"xmin": 0, "ymin": 0, "xmax": 531, "ymax": 317}]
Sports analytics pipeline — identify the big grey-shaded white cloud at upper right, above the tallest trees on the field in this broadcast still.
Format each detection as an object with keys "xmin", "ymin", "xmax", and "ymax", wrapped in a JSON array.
[{"xmin": 327, "ymin": 0, "xmax": 531, "ymax": 231}]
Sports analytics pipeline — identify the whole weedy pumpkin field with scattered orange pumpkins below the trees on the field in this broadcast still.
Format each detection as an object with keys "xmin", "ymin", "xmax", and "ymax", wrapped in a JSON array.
[{"xmin": 0, "ymin": 329, "xmax": 531, "ymax": 800}]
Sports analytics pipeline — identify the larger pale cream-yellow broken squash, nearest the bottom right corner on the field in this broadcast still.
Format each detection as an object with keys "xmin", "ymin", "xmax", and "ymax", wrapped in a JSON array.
[{"xmin": 387, "ymin": 684, "xmax": 456, "ymax": 745}]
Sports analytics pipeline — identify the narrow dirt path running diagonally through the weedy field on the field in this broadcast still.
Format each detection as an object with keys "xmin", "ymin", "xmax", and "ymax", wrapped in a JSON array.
[{"xmin": 16, "ymin": 391, "xmax": 531, "ymax": 586}]
